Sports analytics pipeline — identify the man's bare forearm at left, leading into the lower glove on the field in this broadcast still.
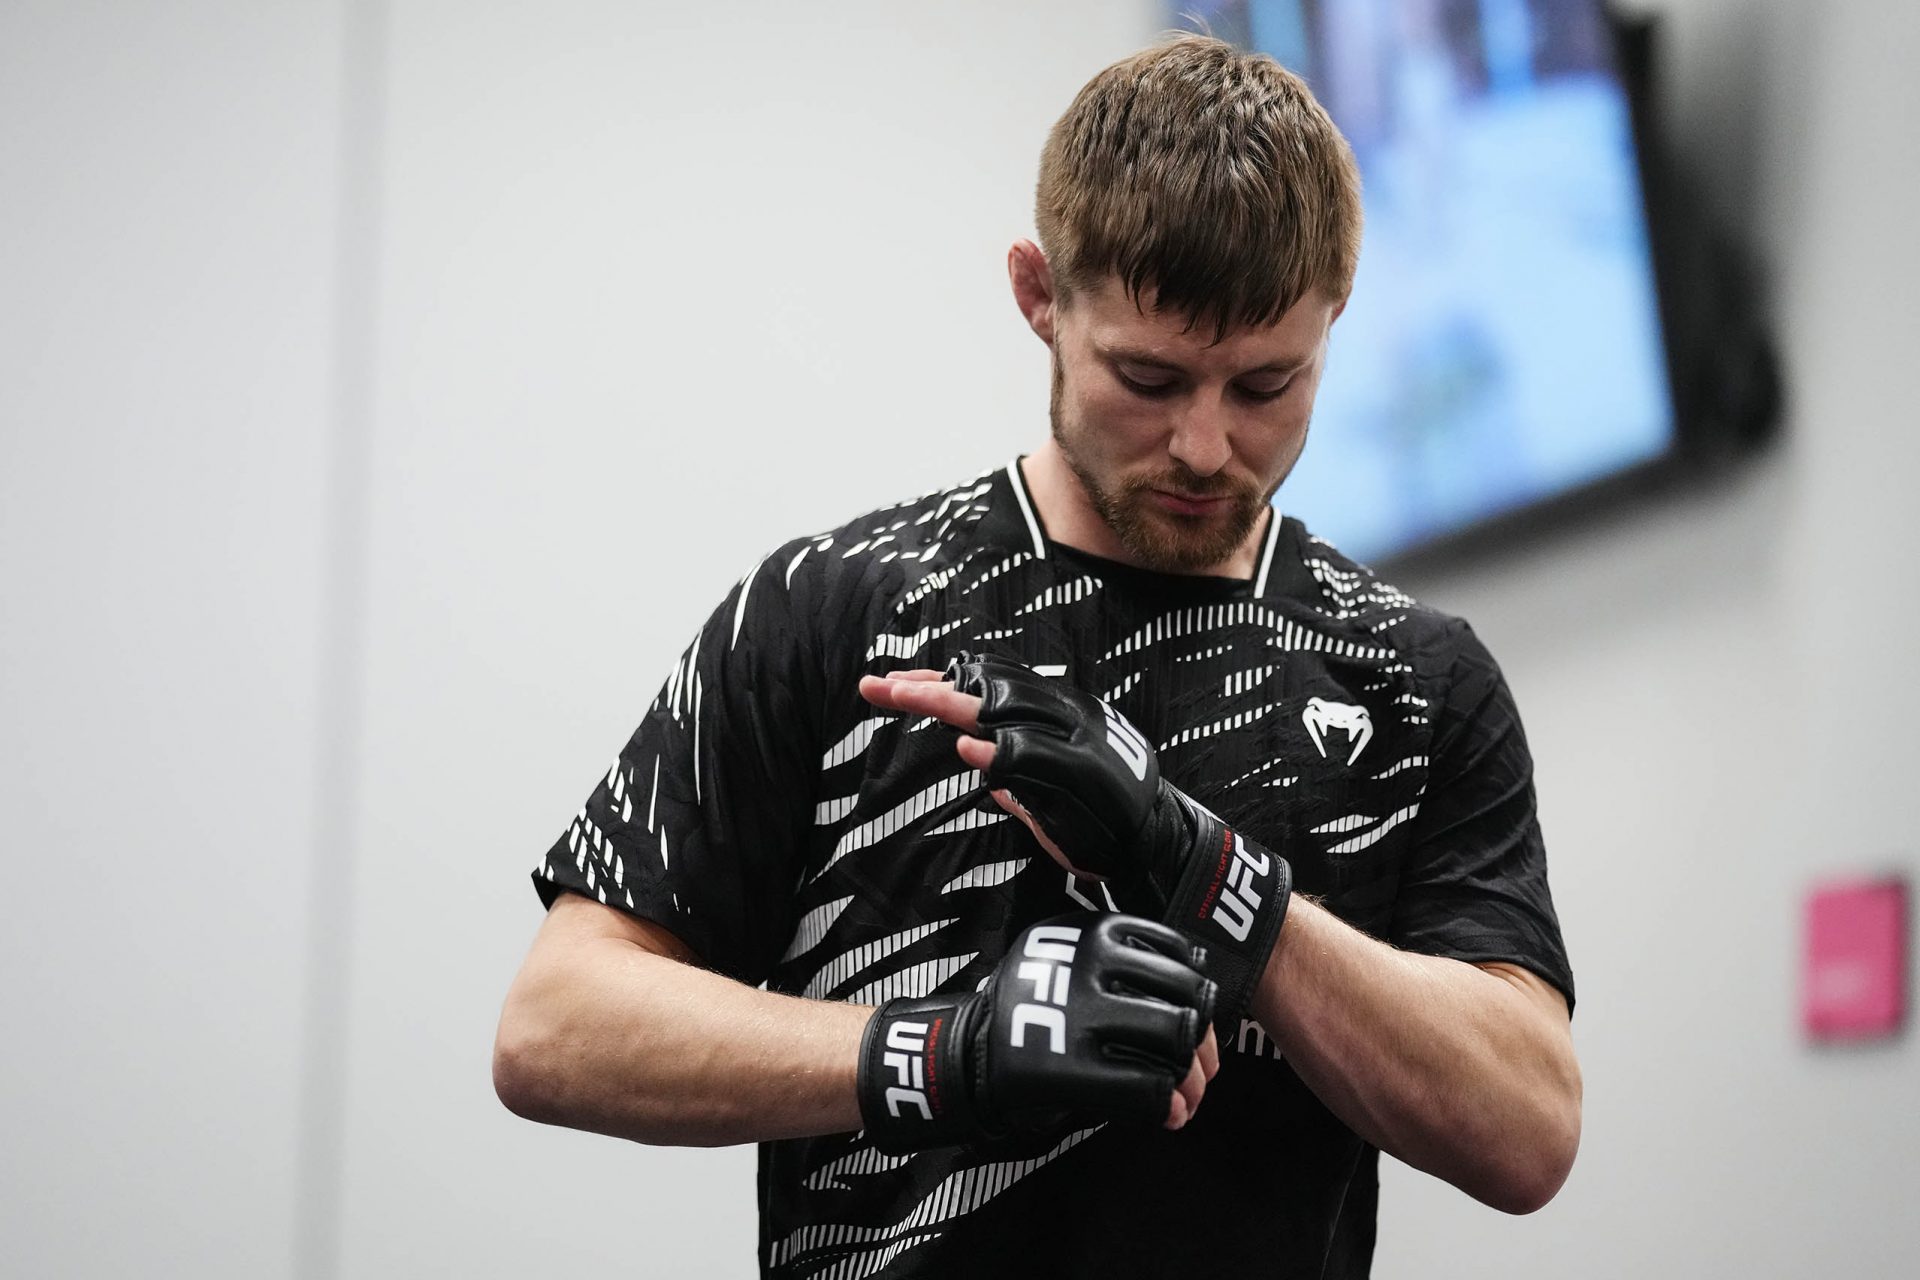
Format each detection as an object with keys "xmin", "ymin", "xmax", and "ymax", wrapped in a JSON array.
[{"xmin": 493, "ymin": 938, "xmax": 874, "ymax": 1146}]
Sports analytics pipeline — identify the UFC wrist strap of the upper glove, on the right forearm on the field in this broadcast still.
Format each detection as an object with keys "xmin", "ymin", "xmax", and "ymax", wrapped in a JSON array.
[{"xmin": 1165, "ymin": 796, "xmax": 1294, "ymax": 1036}]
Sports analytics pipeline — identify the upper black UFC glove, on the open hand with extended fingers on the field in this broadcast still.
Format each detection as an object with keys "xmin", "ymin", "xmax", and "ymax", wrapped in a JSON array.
[{"xmin": 947, "ymin": 652, "xmax": 1294, "ymax": 1032}]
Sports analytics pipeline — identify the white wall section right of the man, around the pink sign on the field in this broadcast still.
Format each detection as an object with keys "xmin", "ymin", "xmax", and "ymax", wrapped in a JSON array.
[{"xmin": 1377, "ymin": 0, "xmax": 1920, "ymax": 1276}]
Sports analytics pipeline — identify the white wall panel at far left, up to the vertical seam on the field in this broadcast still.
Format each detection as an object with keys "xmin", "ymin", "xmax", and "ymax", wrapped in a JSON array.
[{"xmin": 0, "ymin": 0, "xmax": 342, "ymax": 1276}]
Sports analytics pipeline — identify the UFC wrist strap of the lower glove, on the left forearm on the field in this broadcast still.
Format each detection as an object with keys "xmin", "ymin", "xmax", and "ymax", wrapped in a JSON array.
[{"xmin": 856, "ymin": 996, "xmax": 983, "ymax": 1155}]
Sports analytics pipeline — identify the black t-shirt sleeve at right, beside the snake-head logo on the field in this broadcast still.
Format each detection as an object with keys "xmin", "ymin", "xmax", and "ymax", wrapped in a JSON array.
[{"xmin": 1388, "ymin": 622, "xmax": 1574, "ymax": 1009}]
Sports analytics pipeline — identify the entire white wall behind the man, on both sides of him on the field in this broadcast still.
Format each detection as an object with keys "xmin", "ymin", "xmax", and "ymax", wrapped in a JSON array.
[{"xmin": 0, "ymin": 0, "xmax": 1920, "ymax": 1280}]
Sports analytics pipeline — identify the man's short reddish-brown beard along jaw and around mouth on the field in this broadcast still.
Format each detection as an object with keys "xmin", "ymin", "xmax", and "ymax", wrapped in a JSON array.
[{"xmin": 1046, "ymin": 355, "xmax": 1284, "ymax": 574}]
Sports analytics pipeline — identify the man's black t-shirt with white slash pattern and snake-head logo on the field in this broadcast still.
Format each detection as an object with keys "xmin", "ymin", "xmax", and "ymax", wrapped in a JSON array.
[{"xmin": 534, "ymin": 462, "xmax": 1572, "ymax": 1280}]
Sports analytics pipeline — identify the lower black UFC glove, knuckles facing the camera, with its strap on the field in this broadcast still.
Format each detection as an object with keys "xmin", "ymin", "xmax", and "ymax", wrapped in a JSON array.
[{"xmin": 858, "ymin": 912, "xmax": 1213, "ymax": 1153}]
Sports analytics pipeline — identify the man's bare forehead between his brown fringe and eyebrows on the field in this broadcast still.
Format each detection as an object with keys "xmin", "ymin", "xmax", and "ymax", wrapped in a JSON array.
[{"xmin": 1068, "ymin": 276, "xmax": 1334, "ymax": 372}]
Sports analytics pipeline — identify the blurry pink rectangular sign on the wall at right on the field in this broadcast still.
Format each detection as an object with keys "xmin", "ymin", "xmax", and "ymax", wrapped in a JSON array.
[{"xmin": 1801, "ymin": 877, "xmax": 1908, "ymax": 1040}]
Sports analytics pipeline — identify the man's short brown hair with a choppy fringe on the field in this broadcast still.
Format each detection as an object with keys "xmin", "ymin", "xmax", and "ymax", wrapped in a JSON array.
[{"xmin": 1035, "ymin": 35, "xmax": 1361, "ymax": 338}]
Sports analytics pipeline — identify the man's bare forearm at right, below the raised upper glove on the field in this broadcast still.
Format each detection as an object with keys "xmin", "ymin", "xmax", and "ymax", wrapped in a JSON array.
[{"xmin": 1254, "ymin": 898, "xmax": 1580, "ymax": 1213}]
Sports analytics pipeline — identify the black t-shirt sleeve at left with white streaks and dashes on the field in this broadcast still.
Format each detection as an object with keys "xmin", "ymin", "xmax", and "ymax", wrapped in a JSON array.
[{"xmin": 534, "ymin": 545, "xmax": 822, "ymax": 984}]
